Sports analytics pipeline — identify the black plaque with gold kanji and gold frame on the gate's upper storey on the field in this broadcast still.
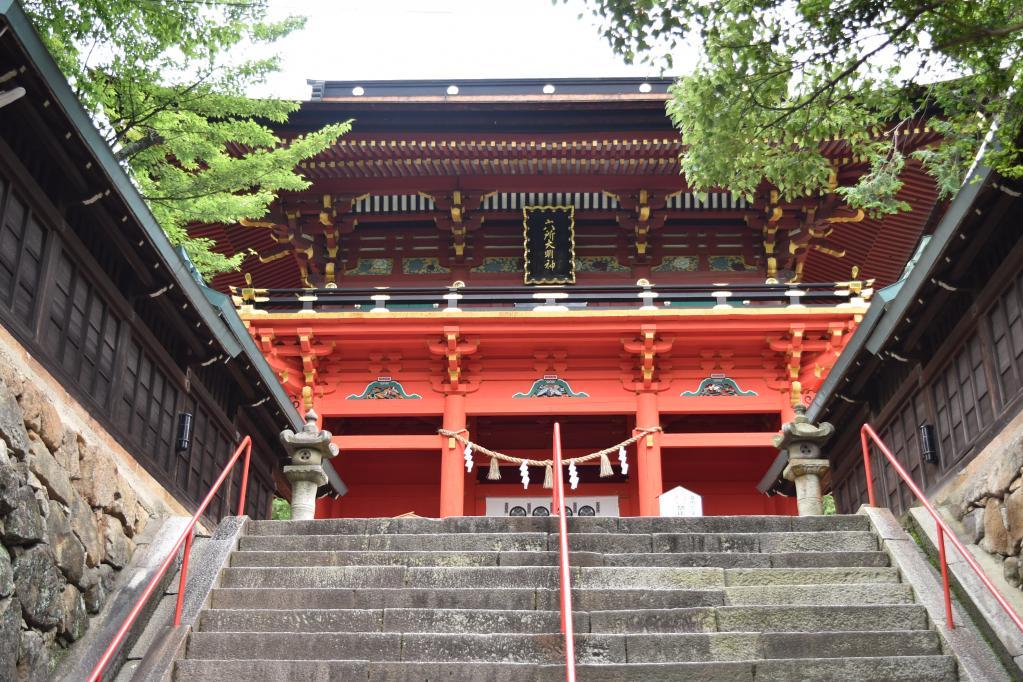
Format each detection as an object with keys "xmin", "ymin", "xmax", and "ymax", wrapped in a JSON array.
[{"xmin": 522, "ymin": 206, "xmax": 575, "ymax": 284}]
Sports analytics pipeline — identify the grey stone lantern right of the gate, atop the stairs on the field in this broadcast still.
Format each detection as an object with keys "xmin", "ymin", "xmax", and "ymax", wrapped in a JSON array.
[{"xmin": 774, "ymin": 405, "xmax": 835, "ymax": 516}]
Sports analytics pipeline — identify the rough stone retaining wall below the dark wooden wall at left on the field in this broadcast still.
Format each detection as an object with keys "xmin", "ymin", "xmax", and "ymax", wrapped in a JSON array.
[{"xmin": 0, "ymin": 359, "xmax": 152, "ymax": 680}]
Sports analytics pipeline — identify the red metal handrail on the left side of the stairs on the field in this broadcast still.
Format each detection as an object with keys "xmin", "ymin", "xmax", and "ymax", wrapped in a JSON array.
[{"xmin": 87, "ymin": 436, "xmax": 253, "ymax": 682}]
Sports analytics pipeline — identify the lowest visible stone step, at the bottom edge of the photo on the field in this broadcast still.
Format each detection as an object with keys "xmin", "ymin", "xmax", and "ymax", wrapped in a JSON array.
[{"xmin": 174, "ymin": 655, "xmax": 959, "ymax": 682}]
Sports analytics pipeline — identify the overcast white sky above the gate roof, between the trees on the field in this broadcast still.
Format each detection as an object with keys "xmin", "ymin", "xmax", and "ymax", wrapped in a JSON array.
[{"xmin": 253, "ymin": 0, "xmax": 682, "ymax": 99}]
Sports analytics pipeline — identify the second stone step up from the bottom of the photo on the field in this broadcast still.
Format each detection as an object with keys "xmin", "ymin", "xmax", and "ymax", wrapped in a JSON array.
[{"xmin": 187, "ymin": 631, "xmax": 939, "ymax": 662}]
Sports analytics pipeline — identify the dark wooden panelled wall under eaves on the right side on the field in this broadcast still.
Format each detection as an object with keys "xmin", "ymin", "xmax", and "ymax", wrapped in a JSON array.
[{"xmin": 832, "ymin": 221, "xmax": 1023, "ymax": 513}]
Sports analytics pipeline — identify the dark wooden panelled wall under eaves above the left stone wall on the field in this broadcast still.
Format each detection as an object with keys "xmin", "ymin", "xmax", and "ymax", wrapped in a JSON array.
[{"xmin": 0, "ymin": 140, "xmax": 276, "ymax": 520}]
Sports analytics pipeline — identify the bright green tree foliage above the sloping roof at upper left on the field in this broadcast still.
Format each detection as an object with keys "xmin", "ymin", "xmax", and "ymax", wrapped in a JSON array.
[{"xmin": 24, "ymin": 0, "xmax": 349, "ymax": 275}]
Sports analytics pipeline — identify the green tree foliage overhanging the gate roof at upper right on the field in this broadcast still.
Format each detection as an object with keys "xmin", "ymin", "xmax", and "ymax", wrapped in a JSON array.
[{"xmin": 568, "ymin": 0, "xmax": 1023, "ymax": 216}]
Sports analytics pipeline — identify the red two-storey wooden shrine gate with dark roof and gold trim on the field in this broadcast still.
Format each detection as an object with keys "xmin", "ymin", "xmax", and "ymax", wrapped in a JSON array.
[{"xmin": 194, "ymin": 79, "xmax": 941, "ymax": 517}]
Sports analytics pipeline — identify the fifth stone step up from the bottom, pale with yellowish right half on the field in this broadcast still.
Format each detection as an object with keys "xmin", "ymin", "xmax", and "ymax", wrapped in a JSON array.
[{"xmin": 213, "ymin": 565, "xmax": 899, "ymax": 589}]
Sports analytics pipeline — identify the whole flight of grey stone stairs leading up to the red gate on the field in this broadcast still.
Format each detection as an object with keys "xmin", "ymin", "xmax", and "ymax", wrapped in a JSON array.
[{"xmin": 167, "ymin": 515, "xmax": 960, "ymax": 682}]
